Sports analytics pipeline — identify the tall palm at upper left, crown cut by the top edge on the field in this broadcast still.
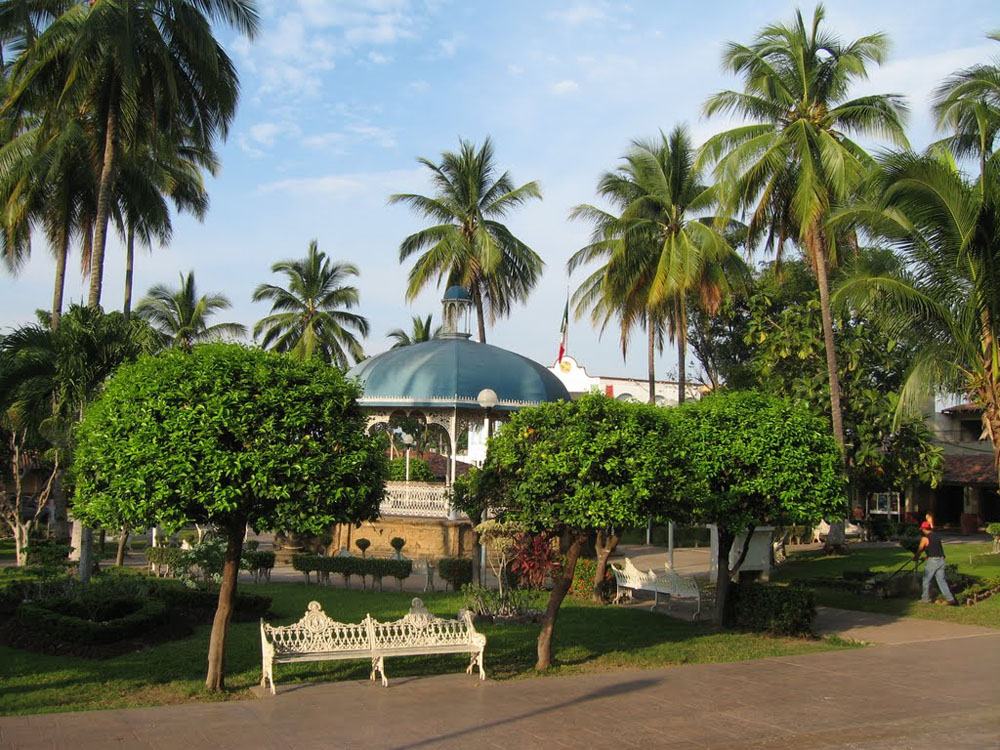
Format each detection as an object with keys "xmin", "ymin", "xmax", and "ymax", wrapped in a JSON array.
[{"xmin": 6, "ymin": 0, "xmax": 258, "ymax": 307}]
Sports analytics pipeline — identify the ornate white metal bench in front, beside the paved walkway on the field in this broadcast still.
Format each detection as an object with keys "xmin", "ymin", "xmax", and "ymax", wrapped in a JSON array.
[{"xmin": 260, "ymin": 598, "xmax": 486, "ymax": 695}]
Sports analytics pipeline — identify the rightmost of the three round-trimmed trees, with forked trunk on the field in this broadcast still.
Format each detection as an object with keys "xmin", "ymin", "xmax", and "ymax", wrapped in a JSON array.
[{"xmin": 667, "ymin": 391, "xmax": 846, "ymax": 625}]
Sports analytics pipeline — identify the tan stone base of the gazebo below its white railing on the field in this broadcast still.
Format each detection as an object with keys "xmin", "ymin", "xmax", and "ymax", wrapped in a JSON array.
[{"xmin": 331, "ymin": 515, "xmax": 472, "ymax": 560}]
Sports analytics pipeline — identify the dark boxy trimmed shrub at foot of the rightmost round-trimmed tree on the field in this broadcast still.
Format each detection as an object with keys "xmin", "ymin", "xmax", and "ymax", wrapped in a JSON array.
[{"xmin": 726, "ymin": 583, "xmax": 816, "ymax": 636}]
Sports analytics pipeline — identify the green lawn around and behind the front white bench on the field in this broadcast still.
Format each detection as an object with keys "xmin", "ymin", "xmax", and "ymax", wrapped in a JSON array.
[{"xmin": 0, "ymin": 583, "xmax": 850, "ymax": 714}]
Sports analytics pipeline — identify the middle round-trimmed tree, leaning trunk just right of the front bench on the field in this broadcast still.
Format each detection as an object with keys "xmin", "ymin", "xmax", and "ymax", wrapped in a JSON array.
[{"xmin": 479, "ymin": 395, "xmax": 688, "ymax": 669}]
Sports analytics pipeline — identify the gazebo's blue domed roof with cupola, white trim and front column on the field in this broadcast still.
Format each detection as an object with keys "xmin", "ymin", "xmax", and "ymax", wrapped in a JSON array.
[{"xmin": 347, "ymin": 286, "xmax": 570, "ymax": 496}]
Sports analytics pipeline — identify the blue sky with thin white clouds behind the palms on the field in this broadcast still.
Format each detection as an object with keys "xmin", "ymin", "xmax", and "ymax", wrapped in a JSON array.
[{"xmin": 0, "ymin": 0, "xmax": 1000, "ymax": 377}]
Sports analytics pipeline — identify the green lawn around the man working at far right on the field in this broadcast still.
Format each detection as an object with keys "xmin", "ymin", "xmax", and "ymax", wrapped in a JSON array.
[{"xmin": 771, "ymin": 544, "xmax": 1000, "ymax": 628}]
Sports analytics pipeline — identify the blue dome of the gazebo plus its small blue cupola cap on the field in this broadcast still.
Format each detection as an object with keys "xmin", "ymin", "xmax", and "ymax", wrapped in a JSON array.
[{"xmin": 347, "ymin": 340, "xmax": 570, "ymax": 411}]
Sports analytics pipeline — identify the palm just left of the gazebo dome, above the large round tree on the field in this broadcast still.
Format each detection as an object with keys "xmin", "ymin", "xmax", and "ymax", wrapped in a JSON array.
[{"xmin": 253, "ymin": 240, "xmax": 368, "ymax": 369}]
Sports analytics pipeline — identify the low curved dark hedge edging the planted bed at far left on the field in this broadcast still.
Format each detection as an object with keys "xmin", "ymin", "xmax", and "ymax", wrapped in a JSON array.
[{"xmin": 14, "ymin": 597, "xmax": 168, "ymax": 646}]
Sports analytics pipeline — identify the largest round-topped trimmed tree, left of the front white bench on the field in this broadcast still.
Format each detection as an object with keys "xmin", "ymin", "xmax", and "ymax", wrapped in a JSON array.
[{"xmin": 74, "ymin": 344, "xmax": 385, "ymax": 690}]
